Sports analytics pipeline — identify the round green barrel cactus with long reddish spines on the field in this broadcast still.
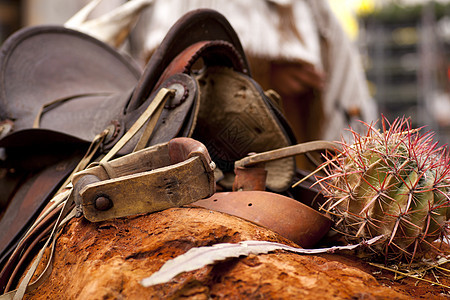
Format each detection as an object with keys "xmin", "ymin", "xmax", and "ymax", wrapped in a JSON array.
[{"xmin": 318, "ymin": 117, "xmax": 450, "ymax": 262}]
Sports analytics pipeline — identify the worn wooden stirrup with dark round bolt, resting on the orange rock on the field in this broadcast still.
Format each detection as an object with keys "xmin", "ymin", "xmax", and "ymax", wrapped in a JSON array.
[{"xmin": 72, "ymin": 138, "xmax": 215, "ymax": 222}]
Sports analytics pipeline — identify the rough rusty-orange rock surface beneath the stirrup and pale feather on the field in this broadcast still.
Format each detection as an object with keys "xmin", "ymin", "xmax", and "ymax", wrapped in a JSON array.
[{"xmin": 26, "ymin": 208, "xmax": 418, "ymax": 300}]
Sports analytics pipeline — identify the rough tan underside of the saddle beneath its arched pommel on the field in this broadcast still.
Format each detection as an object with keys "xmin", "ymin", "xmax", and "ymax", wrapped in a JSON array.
[{"xmin": 193, "ymin": 67, "xmax": 295, "ymax": 192}]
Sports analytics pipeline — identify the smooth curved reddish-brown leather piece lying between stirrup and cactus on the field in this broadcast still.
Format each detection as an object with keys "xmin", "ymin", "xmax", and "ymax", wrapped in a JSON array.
[{"xmin": 192, "ymin": 191, "xmax": 333, "ymax": 248}]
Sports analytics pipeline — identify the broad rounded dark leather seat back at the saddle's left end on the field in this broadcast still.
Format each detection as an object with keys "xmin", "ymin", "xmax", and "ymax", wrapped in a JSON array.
[{"xmin": 0, "ymin": 26, "xmax": 141, "ymax": 146}]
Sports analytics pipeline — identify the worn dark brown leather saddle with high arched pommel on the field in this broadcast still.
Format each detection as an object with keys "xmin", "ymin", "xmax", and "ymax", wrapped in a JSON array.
[{"xmin": 0, "ymin": 9, "xmax": 295, "ymax": 290}]
